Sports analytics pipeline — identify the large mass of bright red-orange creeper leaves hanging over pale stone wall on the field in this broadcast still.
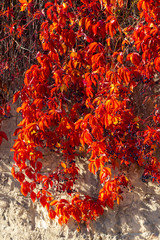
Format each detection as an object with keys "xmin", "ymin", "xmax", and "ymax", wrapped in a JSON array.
[{"xmin": 12, "ymin": 0, "xmax": 160, "ymax": 227}]
